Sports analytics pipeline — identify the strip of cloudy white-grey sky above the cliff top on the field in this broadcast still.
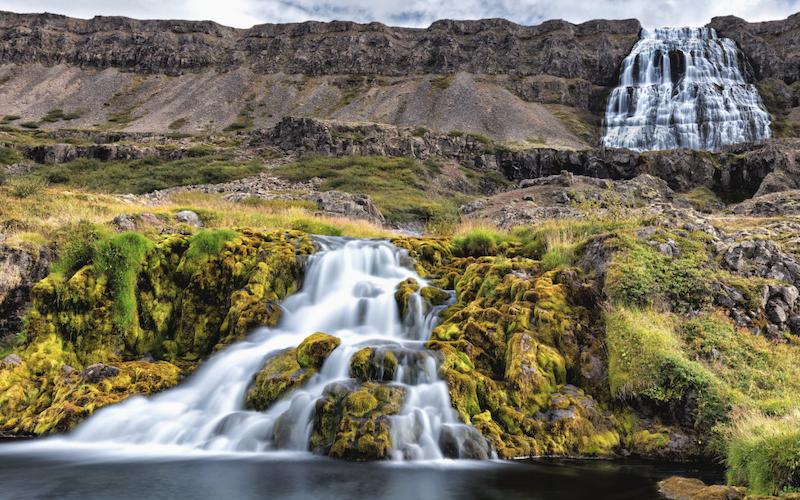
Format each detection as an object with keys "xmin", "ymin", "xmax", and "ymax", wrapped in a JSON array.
[{"xmin": 0, "ymin": 0, "xmax": 800, "ymax": 28}]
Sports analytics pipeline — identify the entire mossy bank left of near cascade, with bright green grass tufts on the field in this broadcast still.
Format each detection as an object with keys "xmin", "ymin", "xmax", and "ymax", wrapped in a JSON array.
[{"xmin": 0, "ymin": 230, "xmax": 314, "ymax": 434}]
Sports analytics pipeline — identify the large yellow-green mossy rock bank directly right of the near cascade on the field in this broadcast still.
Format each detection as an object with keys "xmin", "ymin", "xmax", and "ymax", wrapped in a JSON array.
[{"xmin": 398, "ymin": 238, "xmax": 622, "ymax": 458}]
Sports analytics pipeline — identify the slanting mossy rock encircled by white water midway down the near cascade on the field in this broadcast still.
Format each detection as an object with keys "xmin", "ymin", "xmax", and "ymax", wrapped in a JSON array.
[{"xmin": 244, "ymin": 332, "xmax": 341, "ymax": 411}]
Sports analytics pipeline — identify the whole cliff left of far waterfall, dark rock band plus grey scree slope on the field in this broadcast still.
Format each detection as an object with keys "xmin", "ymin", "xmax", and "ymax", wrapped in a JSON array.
[{"xmin": 0, "ymin": 12, "xmax": 641, "ymax": 149}]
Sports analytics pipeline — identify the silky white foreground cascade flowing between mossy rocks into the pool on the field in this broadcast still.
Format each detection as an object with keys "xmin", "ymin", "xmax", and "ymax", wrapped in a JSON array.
[{"xmin": 50, "ymin": 237, "xmax": 482, "ymax": 459}]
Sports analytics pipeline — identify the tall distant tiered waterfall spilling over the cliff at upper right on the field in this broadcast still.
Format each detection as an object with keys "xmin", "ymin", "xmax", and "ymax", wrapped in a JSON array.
[{"xmin": 603, "ymin": 28, "xmax": 770, "ymax": 151}]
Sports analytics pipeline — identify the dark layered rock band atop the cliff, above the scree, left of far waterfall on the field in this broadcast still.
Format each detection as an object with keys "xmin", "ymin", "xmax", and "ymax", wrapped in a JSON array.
[{"xmin": 0, "ymin": 12, "xmax": 641, "ymax": 86}]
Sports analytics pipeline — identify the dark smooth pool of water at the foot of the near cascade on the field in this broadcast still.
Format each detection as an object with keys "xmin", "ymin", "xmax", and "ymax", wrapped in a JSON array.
[{"xmin": 0, "ymin": 443, "xmax": 723, "ymax": 500}]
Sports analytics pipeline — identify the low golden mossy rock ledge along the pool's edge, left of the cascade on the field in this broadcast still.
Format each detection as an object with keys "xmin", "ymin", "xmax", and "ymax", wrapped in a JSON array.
[{"xmin": 0, "ymin": 361, "xmax": 181, "ymax": 435}]
